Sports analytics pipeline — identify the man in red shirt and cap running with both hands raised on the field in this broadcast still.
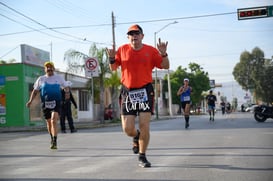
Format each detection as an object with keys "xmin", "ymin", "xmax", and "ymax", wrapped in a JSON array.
[{"xmin": 107, "ymin": 24, "xmax": 169, "ymax": 167}]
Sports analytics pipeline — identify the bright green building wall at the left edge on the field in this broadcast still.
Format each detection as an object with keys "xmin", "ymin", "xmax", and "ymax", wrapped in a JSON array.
[{"xmin": 0, "ymin": 63, "xmax": 44, "ymax": 127}]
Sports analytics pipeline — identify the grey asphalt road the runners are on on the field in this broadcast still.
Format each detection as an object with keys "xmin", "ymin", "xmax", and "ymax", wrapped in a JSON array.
[{"xmin": 0, "ymin": 113, "xmax": 273, "ymax": 181}]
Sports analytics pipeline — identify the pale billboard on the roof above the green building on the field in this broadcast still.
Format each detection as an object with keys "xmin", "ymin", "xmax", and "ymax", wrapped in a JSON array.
[{"xmin": 20, "ymin": 44, "xmax": 50, "ymax": 66}]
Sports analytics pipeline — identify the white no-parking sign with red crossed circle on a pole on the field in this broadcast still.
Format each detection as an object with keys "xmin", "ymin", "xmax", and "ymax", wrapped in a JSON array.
[{"xmin": 85, "ymin": 58, "xmax": 99, "ymax": 77}]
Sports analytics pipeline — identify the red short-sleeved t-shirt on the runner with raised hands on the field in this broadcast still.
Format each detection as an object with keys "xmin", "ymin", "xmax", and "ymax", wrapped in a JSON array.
[{"xmin": 115, "ymin": 44, "xmax": 162, "ymax": 88}]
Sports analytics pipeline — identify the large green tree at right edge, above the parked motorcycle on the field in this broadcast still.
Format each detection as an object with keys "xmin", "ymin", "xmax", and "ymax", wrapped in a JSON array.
[{"xmin": 233, "ymin": 47, "xmax": 273, "ymax": 103}]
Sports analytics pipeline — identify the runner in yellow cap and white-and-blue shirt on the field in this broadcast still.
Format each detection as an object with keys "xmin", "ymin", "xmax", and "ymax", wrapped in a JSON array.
[{"xmin": 26, "ymin": 61, "xmax": 66, "ymax": 149}]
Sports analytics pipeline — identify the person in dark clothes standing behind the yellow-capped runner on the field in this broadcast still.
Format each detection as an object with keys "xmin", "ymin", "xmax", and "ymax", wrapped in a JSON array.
[{"xmin": 60, "ymin": 81, "xmax": 77, "ymax": 133}]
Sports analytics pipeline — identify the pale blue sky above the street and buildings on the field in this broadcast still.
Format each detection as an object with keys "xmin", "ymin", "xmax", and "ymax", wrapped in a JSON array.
[{"xmin": 0, "ymin": 0, "xmax": 273, "ymax": 83}]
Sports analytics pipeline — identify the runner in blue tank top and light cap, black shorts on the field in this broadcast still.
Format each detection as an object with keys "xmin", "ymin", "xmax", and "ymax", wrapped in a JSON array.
[{"xmin": 177, "ymin": 78, "xmax": 192, "ymax": 129}]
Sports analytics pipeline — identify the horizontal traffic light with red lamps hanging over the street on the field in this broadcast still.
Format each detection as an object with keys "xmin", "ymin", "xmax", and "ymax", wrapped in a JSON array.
[{"xmin": 237, "ymin": 6, "xmax": 273, "ymax": 20}]
